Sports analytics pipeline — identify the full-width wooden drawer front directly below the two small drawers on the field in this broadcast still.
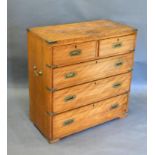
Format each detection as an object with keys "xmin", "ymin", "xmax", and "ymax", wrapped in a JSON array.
[{"xmin": 53, "ymin": 52, "xmax": 133, "ymax": 89}]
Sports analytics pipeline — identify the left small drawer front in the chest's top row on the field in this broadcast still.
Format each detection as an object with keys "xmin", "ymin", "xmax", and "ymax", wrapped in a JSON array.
[{"xmin": 53, "ymin": 41, "xmax": 97, "ymax": 65}]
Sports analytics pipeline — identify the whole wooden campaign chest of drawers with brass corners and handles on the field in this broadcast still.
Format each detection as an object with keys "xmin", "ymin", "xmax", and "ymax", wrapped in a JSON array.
[{"xmin": 28, "ymin": 20, "xmax": 137, "ymax": 142}]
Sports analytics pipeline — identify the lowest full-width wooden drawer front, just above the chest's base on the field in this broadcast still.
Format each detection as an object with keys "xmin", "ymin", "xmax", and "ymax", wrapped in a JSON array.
[{"xmin": 53, "ymin": 95, "xmax": 128, "ymax": 139}]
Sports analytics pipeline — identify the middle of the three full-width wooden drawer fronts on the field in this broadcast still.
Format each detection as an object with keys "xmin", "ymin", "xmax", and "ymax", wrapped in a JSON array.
[{"xmin": 53, "ymin": 72, "xmax": 131, "ymax": 113}]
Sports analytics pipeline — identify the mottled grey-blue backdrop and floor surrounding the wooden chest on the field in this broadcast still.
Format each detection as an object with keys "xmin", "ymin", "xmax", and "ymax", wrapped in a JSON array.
[{"xmin": 8, "ymin": 0, "xmax": 147, "ymax": 155}]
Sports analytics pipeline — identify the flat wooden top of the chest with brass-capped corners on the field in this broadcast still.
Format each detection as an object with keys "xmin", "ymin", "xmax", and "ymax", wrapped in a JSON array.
[{"xmin": 28, "ymin": 20, "xmax": 136, "ymax": 44}]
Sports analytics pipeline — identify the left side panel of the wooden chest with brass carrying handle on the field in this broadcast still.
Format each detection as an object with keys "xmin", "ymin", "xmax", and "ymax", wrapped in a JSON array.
[{"xmin": 28, "ymin": 32, "xmax": 51, "ymax": 139}]
